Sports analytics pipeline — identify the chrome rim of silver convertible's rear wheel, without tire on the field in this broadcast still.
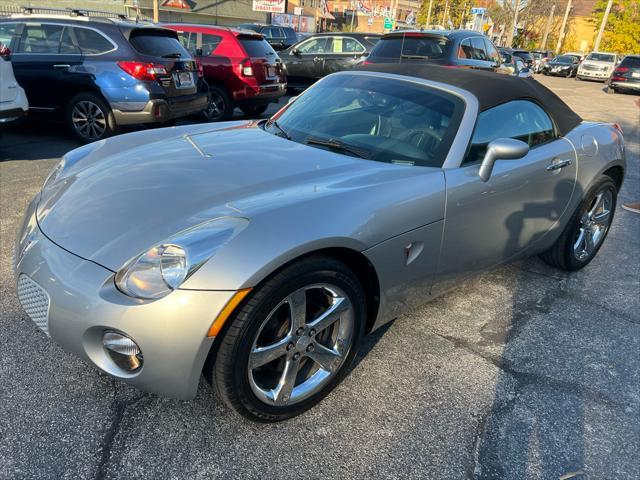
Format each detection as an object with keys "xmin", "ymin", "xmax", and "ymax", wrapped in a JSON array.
[{"xmin": 573, "ymin": 189, "xmax": 613, "ymax": 262}]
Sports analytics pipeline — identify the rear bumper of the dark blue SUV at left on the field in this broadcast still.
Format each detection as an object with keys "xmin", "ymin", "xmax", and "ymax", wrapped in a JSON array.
[{"xmin": 113, "ymin": 94, "xmax": 209, "ymax": 125}]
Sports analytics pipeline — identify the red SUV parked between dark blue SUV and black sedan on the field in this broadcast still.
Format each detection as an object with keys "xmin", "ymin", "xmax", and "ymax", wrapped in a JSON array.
[{"xmin": 164, "ymin": 24, "xmax": 287, "ymax": 121}]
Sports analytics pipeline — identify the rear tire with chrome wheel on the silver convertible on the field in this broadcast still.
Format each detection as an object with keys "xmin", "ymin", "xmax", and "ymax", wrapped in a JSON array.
[{"xmin": 540, "ymin": 175, "xmax": 618, "ymax": 272}]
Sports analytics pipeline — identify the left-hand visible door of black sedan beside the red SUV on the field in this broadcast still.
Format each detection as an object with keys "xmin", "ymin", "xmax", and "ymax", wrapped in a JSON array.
[{"xmin": 285, "ymin": 36, "xmax": 333, "ymax": 83}]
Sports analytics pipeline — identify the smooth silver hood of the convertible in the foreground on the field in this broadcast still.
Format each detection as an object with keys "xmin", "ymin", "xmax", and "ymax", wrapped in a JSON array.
[{"xmin": 37, "ymin": 122, "xmax": 435, "ymax": 271}]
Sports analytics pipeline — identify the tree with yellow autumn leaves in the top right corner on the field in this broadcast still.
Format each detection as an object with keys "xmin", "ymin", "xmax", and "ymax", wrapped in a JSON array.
[{"xmin": 591, "ymin": 0, "xmax": 640, "ymax": 54}]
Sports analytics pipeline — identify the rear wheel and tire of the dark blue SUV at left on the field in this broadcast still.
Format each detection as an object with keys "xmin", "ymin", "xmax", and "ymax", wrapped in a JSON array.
[{"xmin": 65, "ymin": 92, "xmax": 118, "ymax": 143}]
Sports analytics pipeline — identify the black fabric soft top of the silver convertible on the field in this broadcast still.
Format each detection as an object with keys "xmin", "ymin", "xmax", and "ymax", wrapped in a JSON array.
[{"xmin": 354, "ymin": 63, "xmax": 582, "ymax": 135}]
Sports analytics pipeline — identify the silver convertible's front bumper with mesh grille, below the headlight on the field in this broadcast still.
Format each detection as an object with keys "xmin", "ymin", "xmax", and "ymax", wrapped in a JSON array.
[{"xmin": 15, "ymin": 197, "xmax": 234, "ymax": 399}]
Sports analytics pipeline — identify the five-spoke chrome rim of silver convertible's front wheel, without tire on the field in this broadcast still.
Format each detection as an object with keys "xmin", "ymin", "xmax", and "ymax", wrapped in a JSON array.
[{"xmin": 248, "ymin": 284, "xmax": 355, "ymax": 406}]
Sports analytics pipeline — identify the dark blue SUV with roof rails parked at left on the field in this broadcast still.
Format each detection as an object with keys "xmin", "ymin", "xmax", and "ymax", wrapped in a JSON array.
[{"xmin": 0, "ymin": 11, "xmax": 209, "ymax": 142}]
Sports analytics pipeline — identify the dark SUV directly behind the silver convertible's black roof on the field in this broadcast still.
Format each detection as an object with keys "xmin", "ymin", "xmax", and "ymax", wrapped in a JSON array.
[{"xmin": 364, "ymin": 30, "xmax": 500, "ymax": 71}]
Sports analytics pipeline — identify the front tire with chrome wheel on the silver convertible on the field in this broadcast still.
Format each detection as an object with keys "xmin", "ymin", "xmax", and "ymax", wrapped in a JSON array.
[{"xmin": 211, "ymin": 256, "xmax": 366, "ymax": 422}]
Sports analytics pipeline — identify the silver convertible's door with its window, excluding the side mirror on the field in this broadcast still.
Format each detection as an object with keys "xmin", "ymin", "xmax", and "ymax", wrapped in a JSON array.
[{"xmin": 438, "ymin": 100, "xmax": 576, "ymax": 289}]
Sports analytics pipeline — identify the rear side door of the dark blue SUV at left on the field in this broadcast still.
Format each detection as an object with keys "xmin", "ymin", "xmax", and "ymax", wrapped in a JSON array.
[{"xmin": 13, "ymin": 22, "xmax": 82, "ymax": 111}]
